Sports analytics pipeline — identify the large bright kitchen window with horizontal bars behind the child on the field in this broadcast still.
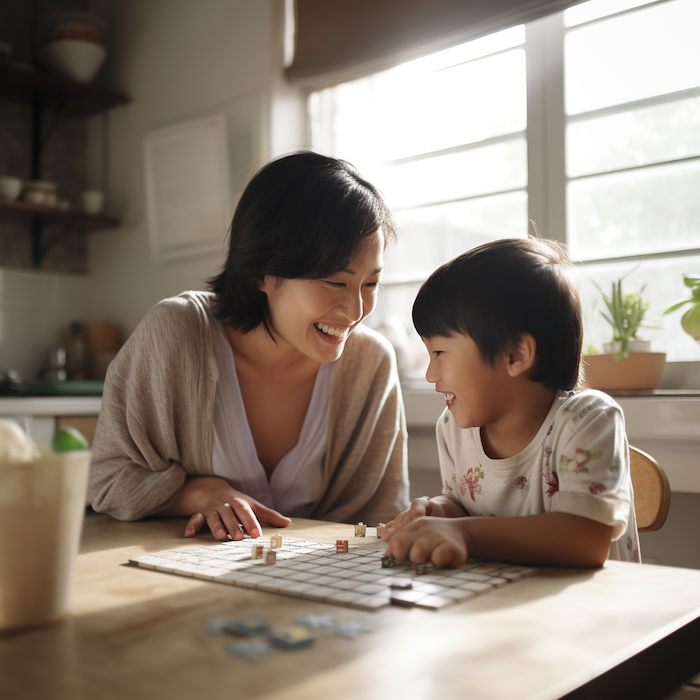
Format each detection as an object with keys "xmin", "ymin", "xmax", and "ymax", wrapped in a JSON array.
[{"xmin": 309, "ymin": 0, "xmax": 700, "ymax": 382}]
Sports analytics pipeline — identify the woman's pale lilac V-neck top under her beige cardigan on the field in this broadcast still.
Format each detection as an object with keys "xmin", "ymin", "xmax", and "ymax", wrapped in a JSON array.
[{"xmin": 211, "ymin": 316, "xmax": 337, "ymax": 518}]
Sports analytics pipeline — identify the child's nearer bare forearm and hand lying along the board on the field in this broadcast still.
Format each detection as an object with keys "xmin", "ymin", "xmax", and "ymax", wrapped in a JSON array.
[{"xmin": 382, "ymin": 513, "xmax": 613, "ymax": 567}]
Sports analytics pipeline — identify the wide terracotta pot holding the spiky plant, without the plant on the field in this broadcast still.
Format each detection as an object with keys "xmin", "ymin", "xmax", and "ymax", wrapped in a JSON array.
[{"xmin": 583, "ymin": 352, "xmax": 666, "ymax": 391}]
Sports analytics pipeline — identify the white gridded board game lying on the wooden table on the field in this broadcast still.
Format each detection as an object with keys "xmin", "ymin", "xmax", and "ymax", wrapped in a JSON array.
[{"xmin": 129, "ymin": 535, "xmax": 537, "ymax": 610}]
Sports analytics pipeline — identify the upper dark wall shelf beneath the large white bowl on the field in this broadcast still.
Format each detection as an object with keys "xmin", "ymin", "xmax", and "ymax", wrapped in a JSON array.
[{"xmin": 0, "ymin": 63, "xmax": 130, "ymax": 117}]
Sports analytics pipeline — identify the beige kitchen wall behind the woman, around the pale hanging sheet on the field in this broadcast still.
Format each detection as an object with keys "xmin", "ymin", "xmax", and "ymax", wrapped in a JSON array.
[{"xmin": 0, "ymin": 0, "xmax": 305, "ymax": 377}]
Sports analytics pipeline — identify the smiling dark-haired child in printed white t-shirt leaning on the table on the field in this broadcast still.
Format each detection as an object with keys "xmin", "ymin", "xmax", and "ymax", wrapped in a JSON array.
[{"xmin": 383, "ymin": 238, "xmax": 639, "ymax": 566}]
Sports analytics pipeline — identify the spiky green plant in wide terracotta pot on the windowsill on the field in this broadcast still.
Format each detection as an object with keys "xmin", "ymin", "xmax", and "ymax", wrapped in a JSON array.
[{"xmin": 584, "ymin": 277, "xmax": 666, "ymax": 391}]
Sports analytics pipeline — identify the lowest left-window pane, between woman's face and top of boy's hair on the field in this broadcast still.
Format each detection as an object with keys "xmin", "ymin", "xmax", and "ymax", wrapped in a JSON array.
[{"xmin": 384, "ymin": 192, "xmax": 528, "ymax": 285}]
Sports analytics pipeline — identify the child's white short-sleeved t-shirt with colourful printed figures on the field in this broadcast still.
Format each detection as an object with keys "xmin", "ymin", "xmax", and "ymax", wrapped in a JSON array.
[{"xmin": 436, "ymin": 389, "xmax": 640, "ymax": 562}]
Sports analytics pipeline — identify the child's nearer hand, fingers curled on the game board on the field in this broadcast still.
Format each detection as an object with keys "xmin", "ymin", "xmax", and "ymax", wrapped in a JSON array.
[{"xmin": 382, "ymin": 516, "xmax": 472, "ymax": 567}]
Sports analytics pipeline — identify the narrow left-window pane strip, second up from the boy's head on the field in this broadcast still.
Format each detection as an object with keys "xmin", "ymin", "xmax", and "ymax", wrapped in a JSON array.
[{"xmin": 367, "ymin": 138, "xmax": 527, "ymax": 208}]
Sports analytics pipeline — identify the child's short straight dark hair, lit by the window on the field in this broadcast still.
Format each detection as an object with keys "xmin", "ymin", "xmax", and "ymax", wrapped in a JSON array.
[{"xmin": 413, "ymin": 238, "xmax": 583, "ymax": 390}]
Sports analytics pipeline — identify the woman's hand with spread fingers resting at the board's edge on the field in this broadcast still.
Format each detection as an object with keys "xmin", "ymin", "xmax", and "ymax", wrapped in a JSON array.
[{"xmin": 160, "ymin": 476, "xmax": 292, "ymax": 540}]
